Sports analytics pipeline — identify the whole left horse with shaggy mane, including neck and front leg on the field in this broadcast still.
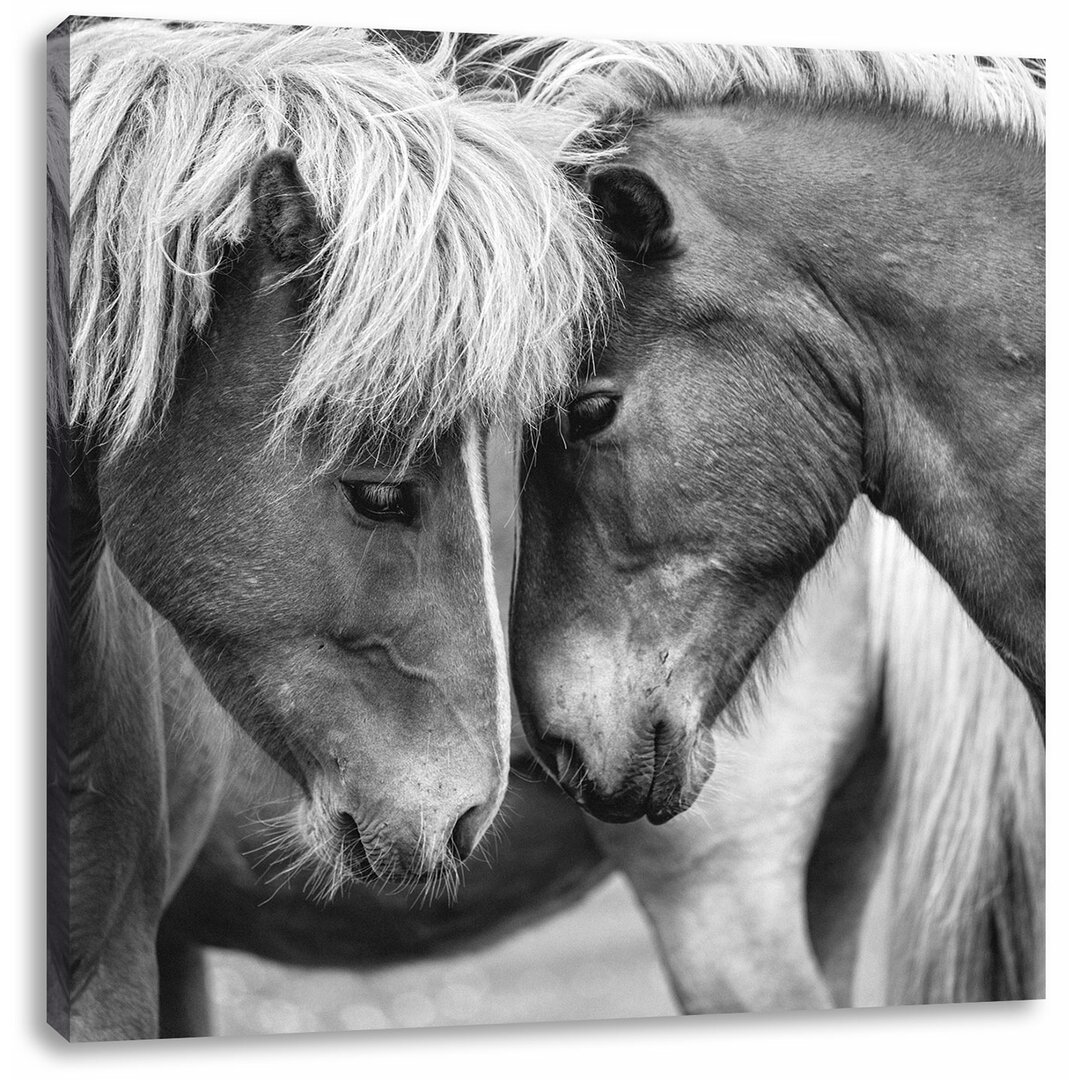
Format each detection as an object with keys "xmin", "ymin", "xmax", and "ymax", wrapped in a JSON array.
[{"xmin": 48, "ymin": 23, "xmax": 610, "ymax": 1039}]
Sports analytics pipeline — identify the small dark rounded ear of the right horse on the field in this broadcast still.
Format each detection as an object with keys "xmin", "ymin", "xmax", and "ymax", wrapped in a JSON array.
[{"xmin": 585, "ymin": 164, "xmax": 677, "ymax": 259}]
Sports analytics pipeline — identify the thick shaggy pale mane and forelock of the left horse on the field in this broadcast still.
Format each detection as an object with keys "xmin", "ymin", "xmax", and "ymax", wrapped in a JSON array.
[{"xmin": 56, "ymin": 21, "xmax": 612, "ymax": 460}]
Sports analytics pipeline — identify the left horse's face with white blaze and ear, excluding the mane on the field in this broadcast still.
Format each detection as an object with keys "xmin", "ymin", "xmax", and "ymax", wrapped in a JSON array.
[{"xmin": 99, "ymin": 151, "xmax": 510, "ymax": 888}]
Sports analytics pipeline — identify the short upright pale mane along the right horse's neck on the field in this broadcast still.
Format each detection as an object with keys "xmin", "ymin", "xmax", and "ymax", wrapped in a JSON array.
[{"xmin": 465, "ymin": 37, "xmax": 1045, "ymax": 163}]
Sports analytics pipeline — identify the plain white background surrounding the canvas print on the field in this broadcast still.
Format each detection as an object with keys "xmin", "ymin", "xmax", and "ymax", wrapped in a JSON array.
[{"xmin": 0, "ymin": 0, "xmax": 1080, "ymax": 1080}]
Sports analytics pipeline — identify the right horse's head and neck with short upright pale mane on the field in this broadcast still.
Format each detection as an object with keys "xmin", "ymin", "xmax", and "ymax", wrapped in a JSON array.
[{"xmin": 475, "ymin": 42, "xmax": 1044, "ymax": 821}]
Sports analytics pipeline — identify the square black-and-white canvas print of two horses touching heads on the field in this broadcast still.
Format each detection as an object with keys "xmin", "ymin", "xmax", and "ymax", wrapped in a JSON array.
[{"xmin": 46, "ymin": 17, "xmax": 1045, "ymax": 1041}]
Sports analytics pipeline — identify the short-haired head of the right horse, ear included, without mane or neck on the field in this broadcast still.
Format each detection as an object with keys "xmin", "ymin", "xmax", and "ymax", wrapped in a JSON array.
[{"xmin": 511, "ymin": 135, "xmax": 861, "ymax": 822}]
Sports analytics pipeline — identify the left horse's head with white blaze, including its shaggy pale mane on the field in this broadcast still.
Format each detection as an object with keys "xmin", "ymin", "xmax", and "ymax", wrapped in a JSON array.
[{"xmin": 68, "ymin": 24, "xmax": 611, "ymax": 893}]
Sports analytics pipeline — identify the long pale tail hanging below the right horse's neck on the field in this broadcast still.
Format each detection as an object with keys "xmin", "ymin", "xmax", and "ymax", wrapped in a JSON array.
[{"xmin": 869, "ymin": 514, "xmax": 1045, "ymax": 1004}]
